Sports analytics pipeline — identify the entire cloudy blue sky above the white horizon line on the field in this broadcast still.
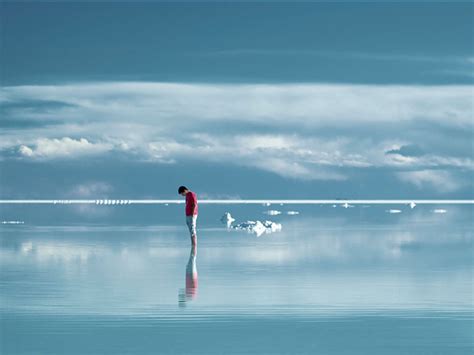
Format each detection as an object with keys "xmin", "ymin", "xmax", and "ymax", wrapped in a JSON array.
[{"xmin": 0, "ymin": 1, "xmax": 474, "ymax": 199}]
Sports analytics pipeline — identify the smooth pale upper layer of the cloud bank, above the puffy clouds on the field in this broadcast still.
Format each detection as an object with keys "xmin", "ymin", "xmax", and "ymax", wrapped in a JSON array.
[{"xmin": 0, "ymin": 82, "xmax": 473, "ymax": 127}]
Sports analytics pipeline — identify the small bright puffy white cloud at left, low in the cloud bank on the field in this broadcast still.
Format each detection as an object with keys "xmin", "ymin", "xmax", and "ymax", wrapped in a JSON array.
[{"xmin": 18, "ymin": 137, "xmax": 113, "ymax": 158}]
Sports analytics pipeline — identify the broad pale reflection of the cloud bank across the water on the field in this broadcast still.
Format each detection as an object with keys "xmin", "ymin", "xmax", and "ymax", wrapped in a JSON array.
[{"xmin": 0, "ymin": 218, "xmax": 473, "ymax": 317}]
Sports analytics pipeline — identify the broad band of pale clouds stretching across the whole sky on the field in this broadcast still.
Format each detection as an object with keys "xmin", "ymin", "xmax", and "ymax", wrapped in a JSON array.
[{"xmin": 0, "ymin": 82, "xmax": 474, "ymax": 192}]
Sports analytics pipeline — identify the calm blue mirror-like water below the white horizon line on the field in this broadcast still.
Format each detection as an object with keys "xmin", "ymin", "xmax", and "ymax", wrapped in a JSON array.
[{"xmin": 0, "ymin": 205, "xmax": 474, "ymax": 354}]
